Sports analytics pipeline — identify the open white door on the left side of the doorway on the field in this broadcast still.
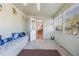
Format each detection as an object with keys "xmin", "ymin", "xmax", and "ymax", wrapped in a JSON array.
[{"xmin": 30, "ymin": 17, "xmax": 36, "ymax": 41}]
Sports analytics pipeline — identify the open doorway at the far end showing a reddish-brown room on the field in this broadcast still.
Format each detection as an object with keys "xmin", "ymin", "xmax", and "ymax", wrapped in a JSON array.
[{"xmin": 36, "ymin": 20, "xmax": 43, "ymax": 40}]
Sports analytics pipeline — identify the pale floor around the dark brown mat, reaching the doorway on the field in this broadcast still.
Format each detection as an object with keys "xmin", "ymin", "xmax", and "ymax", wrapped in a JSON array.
[{"xmin": 24, "ymin": 40, "xmax": 71, "ymax": 56}]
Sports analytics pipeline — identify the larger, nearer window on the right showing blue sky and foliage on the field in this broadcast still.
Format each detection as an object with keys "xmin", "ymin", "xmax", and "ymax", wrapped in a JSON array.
[{"xmin": 65, "ymin": 6, "xmax": 79, "ymax": 35}]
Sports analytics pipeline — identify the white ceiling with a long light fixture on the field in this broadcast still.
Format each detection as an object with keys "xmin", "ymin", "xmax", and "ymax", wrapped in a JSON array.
[{"xmin": 14, "ymin": 3, "xmax": 63, "ymax": 17}]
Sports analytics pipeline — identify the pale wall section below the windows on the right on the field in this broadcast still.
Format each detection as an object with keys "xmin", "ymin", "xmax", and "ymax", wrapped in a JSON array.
[{"xmin": 54, "ymin": 32, "xmax": 79, "ymax": 56}]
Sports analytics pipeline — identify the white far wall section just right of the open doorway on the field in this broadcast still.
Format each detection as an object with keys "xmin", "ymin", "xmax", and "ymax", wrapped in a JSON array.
[{"xmin": 43, "ymin": 19, "xmax": 53, "ymax": 39}]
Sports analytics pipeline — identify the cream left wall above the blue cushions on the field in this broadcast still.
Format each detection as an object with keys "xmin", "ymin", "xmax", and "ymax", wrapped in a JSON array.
[{"xmin": 0, "ymin": 4, "xmax": 26, "ymax": 38}]
